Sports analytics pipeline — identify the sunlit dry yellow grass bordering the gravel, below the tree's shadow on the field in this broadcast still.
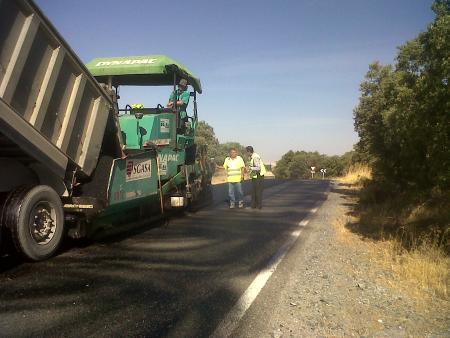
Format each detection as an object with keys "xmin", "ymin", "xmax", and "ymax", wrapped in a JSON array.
[{"xmin": 333, "ymin": 211, "xmax": 450, "ymax": 301}]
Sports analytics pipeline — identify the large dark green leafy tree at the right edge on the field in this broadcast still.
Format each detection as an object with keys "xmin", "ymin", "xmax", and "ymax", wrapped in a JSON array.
[{"xmin": 354, "ymin": 0, "xmax": 450, "ymax": 195}]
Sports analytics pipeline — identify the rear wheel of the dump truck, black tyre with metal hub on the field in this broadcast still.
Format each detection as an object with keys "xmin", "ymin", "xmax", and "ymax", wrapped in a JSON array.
[{"xmin": 4, "ymin": 185, "xmax": 64, "ymax": 261}]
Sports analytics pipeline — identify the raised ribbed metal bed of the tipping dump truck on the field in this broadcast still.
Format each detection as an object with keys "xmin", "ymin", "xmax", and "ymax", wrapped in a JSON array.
[{"xmin": 0, "ymin": 0, "xmax": 112, "ymax": 176}]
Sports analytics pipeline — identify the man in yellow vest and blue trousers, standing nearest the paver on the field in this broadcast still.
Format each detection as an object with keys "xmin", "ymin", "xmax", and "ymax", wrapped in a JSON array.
[{"xmin": 223, "ymin": 148, "xmax": 245, "ymax": 209}]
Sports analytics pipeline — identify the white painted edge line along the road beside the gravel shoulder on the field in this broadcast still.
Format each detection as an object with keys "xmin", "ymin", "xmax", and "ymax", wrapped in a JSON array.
[{"xmin": 210, "ymin": 208, "xmax": 318, "ymax": 338}]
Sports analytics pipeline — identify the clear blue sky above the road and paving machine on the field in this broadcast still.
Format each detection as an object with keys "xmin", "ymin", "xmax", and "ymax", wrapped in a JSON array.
[{"xmin": 37, "ymin": 0, "xmax": 434, "ymax": 162}]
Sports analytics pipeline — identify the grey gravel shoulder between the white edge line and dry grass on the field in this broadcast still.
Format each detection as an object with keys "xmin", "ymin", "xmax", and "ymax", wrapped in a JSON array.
[{"xmin": 232, "ymin": 182, "xmax": 450, "ymax": 337}]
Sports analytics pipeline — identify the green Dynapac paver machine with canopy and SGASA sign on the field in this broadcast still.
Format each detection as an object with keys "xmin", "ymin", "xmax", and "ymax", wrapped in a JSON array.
[{"xmin": 86, "ymin": 55, "xmax": 214, "ymax": 218}]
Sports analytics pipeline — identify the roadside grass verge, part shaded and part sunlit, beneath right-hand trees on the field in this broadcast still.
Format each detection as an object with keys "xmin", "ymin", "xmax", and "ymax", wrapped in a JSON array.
[{"xmin": 334, "ymin": 166, "xmax": 450, "ymax": 300}]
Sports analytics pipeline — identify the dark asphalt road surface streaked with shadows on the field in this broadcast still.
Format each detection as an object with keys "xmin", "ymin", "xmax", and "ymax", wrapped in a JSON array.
[{"xmin": 0, "ymin": 180, "xmax": 329, "ymax": 337}]
